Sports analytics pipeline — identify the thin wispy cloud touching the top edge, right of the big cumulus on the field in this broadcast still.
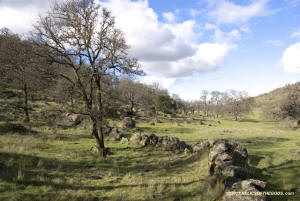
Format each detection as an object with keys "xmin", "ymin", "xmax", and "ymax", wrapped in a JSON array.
[{"xmin": 209, "ymin": 0, "xmax": 273, "ymax": 24}]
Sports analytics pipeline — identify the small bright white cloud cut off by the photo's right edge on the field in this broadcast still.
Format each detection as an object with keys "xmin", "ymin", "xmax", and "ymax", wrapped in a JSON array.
[{"xmin": 281, "ymin": 42, "xmax": 300, "ymax": 73}]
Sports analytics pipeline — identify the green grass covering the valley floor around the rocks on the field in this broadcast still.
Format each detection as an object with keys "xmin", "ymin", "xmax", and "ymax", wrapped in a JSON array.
[{"xmin": 0, "ymin": 115, "xmax": 300, "ymax": 201}]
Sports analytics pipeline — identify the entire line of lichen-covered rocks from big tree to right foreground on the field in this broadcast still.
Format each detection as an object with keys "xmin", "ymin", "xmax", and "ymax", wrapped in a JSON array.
[{"xmin": 103, "ymin": 131, "xmax": 270, "ymax": 201}]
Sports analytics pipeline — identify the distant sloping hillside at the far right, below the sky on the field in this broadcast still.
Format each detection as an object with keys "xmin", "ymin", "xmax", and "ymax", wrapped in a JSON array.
[{"xmin": 255, "ymin": 82, "xmax": 300, "ymax": 119}]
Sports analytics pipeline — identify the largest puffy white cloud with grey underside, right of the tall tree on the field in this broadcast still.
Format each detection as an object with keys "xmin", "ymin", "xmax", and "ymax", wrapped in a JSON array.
[{"xmin": 102, "ymin": 0, "xmax": 237, "ymax": 79}]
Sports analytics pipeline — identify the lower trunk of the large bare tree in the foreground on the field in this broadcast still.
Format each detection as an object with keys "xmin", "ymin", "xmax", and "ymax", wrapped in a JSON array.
[{"xmin": 91, "ymin": 118, "xmax": 106, "ymax": 158}]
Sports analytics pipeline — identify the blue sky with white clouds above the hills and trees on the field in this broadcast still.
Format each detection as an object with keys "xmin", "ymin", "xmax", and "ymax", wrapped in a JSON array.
[{"xmin": 0, "ymin": 0, "xmax": 300, "ymax": 100}]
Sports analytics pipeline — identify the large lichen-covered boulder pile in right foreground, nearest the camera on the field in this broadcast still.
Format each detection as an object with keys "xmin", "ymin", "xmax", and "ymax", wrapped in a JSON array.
[{"xmin": 192, "ymin": 140, "xmax": 270, "ymax": 201}]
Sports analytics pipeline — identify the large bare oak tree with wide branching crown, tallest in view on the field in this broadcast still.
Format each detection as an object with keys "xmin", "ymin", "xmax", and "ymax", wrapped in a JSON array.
[{"xmin": 34, "ymin": 0, "xmax": 141, "ymax": 157}]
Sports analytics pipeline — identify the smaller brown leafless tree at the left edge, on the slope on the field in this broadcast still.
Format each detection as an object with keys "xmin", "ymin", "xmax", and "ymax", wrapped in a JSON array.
[{"xmin": 0, "ymin": 28, "xmax": 52, "ymax": 122}]
